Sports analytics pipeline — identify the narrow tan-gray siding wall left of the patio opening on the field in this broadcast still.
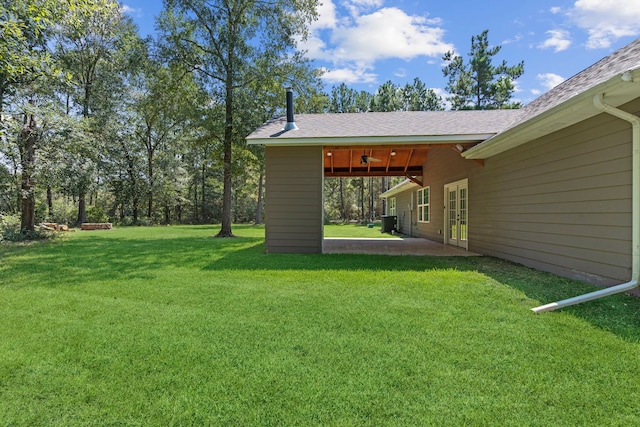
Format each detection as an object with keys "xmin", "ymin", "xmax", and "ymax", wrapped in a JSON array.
[{"xmin": 265, "ymin": 147, "xmax": 323, "ymax": 253}]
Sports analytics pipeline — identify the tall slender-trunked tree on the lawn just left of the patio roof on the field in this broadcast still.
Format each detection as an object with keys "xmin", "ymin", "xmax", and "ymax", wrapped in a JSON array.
[{"xmin": 160, "ymin": 0, "xmax": 317, "ymax": 237}]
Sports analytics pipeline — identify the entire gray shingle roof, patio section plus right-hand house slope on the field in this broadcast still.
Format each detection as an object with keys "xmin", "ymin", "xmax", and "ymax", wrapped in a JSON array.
[{"xmin": 247, "ymin": 39, "xmax": 640, "ymax": 145}]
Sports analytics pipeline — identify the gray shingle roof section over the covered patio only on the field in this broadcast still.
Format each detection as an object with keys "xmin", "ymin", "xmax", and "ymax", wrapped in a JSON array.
[{"xmin": 247, "ymin": 110, "xmax": 519, "ymax": 140}]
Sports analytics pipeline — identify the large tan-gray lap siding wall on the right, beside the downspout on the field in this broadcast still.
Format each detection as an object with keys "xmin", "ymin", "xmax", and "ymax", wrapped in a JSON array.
[{"xmin": 469, "ymin": 103, "xmax": 638, "ymax": 285}]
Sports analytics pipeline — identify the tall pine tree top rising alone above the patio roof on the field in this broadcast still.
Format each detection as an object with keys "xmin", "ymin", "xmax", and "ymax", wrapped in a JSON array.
[{"xmin": 442, "ymin": 30, "xmax": 524, "ymax": 110}]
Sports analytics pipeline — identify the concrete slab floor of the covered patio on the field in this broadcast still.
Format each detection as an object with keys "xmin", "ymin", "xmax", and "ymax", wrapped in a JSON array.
[{"xmin": 324, "ymin": 237, "xmax": 479, "ymax": 256}]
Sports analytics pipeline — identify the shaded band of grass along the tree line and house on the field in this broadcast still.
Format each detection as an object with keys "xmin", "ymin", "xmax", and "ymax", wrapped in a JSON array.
[{"xmin": 0, "ymin": 228, "xmax": 640, "ymax": 342}]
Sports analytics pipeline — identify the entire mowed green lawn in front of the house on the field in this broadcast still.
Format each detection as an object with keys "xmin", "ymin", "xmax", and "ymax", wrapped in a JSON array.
[{"xmin": 0, "ymin": 226, "xmax": 640, "ymax": 426}]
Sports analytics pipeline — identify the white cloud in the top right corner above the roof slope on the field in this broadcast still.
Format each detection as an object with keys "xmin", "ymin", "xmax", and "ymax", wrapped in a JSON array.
[{"xmin": 568, "ymin": 0, "xmax": 640, "ymax": 49}]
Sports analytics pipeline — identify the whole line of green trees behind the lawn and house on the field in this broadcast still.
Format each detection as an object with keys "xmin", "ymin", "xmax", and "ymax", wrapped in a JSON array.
[{"xmin": 0, "ymin": 0, "xmax": 523, "ymax": 237}]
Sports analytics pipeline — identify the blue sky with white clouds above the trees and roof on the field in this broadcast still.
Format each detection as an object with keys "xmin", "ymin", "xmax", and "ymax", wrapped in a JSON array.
[{"xmin": 122, "ymin": 0, "xmax": 640, "ymax": 103}]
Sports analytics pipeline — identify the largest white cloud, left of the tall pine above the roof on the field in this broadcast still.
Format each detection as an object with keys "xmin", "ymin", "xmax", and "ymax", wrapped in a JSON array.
[{"xmin": 299, "ymin": 0, "xmax": 454, "ymax": 83}]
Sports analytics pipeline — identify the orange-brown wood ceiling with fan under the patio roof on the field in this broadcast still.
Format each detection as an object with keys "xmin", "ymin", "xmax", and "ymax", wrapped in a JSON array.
[{"xmin": 322, "ymin": 144, "xmax": 473, "ymax": 177}]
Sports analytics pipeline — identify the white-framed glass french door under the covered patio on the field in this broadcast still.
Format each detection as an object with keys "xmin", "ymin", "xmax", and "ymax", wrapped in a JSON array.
[{"xmin": 444, "ymin": 179, "xmax": 469, "ymax": 249}]
